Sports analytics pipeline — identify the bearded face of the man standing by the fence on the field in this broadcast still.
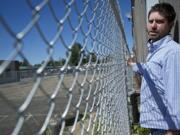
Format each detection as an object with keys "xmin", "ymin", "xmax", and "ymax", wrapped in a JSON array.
[{"xmin": 147, "ymin": 12, "xmax": 172, "ymax": 41}]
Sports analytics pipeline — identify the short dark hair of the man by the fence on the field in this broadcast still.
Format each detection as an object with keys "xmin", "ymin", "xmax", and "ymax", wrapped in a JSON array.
[{"xmin": 148, "ymin": 3, "xmax": 176, "ymax": 23}]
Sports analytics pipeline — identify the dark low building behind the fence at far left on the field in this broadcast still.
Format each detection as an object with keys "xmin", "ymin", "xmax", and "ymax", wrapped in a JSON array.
[{"xmin": 0, "ymin": 60, "xmax": 20, "ymax": 84}]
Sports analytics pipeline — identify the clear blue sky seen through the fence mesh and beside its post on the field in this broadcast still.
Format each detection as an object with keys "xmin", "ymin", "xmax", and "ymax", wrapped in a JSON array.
[{"xmin": 0, "ymin": 0, "xmax": 132, "ymax": 64}]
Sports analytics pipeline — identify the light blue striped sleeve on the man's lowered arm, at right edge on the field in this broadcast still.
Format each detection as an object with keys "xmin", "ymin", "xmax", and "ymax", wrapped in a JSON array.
[{"xmin": 164, "ymin": 51, "xmax": 180, "ymax": 122}]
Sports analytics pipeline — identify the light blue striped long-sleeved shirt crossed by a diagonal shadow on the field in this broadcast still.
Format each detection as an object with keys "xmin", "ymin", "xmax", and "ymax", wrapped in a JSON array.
[{"xmin": 133, "ymin": 35, "xmax": 180, "ymax": 130}]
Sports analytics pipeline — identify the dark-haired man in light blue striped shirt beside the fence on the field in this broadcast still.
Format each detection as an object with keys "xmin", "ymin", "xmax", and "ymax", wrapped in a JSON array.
[{"xmin": 127, "ymin": 3, "xmax": 180, "ymax": 135}]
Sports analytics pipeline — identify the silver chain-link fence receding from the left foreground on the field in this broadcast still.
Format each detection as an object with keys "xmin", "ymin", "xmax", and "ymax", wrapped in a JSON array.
[{"xmin": 0, "ymin": 0, "xmax": 130, "ymax": 135}]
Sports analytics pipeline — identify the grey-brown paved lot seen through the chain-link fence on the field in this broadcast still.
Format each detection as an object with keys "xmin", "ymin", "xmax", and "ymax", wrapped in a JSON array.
[{"xmin": 0, "ymin": 75, "xmax": 95, "ymax": 135}]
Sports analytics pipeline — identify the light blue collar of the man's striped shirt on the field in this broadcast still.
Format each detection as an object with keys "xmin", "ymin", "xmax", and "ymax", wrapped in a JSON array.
[{"xmin": 148, "ymin": 34, "xmax": 172, "ymax": 52}]
